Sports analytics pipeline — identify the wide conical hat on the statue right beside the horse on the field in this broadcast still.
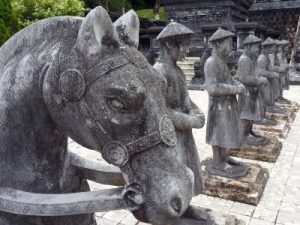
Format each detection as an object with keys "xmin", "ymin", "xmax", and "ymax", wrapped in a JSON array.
[{"xmin": 156, "ymin": 20, "xmax": 194, "ymax": 40}]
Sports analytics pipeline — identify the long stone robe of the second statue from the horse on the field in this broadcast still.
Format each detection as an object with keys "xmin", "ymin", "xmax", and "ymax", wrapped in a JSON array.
[{"xmin": 204, "ymin": 54, "xmax": 243, "ymax": 149}]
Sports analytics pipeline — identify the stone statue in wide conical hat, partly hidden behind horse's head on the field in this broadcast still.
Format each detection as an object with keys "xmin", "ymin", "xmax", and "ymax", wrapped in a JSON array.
[{"xmin": 154, "ymin": 22, "xmax": 205, "ymax": 195}]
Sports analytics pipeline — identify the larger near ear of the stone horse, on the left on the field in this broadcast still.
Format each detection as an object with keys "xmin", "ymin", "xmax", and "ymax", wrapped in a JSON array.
[{"xmin": 75, "ymin": 6, "xmax": 120, "ymax": 56}]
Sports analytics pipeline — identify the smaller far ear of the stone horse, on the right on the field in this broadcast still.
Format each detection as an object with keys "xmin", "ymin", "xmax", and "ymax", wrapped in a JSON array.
[{"xmin": 114, "ymin": 10, "xmax": 140, "ymax": 48}]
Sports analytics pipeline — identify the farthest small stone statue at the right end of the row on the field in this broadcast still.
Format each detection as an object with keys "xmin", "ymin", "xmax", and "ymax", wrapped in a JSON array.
[{"xmin": 277, "ymin": 40, "xmax": 291, "ymax": 104}]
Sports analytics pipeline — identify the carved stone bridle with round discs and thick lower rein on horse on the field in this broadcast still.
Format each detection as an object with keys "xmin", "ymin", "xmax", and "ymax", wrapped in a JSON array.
[{"xmin": 0, "ymin": 47, "xmax": 177, "ymax": 216}]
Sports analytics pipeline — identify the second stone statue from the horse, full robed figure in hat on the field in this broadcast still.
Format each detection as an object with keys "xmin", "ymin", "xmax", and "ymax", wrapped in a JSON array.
[{"xmin": 204, "ymin": 28, "xmax": 249, "ymax": 178}]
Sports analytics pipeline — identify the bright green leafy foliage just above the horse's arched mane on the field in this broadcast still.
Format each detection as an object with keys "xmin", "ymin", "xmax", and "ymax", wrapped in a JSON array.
[{"xmin": 12, "ymin": 0, "xmax": 84, "ymax": 27}]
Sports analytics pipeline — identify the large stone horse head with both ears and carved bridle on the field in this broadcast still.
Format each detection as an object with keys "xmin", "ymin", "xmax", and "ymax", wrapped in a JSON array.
[{"xmin": 43, "ymin": 7, "xmax": 193, "ymax": 225}]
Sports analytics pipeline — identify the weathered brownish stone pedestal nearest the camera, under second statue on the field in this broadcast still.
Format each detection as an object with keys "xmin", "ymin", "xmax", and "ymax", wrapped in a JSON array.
[{"xmin": 202, "ymin": 159, "xmax": 269, "ymax": 205}]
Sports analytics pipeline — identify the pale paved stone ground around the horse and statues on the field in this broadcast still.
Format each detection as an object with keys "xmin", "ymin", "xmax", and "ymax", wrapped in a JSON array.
[{"xmin": 69, "ymin": 86, "xmax": 300, "ymax": 225}]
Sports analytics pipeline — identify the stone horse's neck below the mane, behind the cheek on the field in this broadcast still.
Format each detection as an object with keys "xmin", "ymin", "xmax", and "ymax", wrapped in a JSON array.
[{"xmin": 0, "ymin": 44, "xmax": 71, "ymax": 192}]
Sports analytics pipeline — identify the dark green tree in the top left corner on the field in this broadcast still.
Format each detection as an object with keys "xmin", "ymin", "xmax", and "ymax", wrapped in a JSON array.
[{"xmin": 0, "ymin": 0, "xmax": 18, "ymax": 46}]
